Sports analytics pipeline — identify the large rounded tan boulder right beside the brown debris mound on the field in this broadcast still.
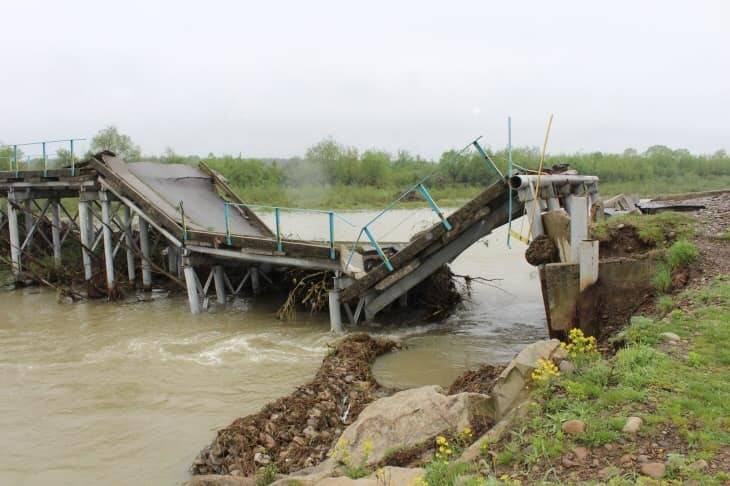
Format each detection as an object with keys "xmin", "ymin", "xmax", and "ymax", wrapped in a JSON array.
[{"xmin": 330, "ymin": 386, "xmax": 494, "ymax": 466}]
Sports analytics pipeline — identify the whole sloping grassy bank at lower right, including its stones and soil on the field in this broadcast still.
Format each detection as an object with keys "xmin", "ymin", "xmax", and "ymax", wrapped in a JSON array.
[{"xmin": 412, "ymin": 275, "xmax": 730, "ymax": 486}]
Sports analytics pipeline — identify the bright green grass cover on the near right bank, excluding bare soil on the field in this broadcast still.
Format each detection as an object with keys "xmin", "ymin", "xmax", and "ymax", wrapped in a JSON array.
[{"xmin": 496, "ymin": 276, "xmax": 730, "ymax": 485}]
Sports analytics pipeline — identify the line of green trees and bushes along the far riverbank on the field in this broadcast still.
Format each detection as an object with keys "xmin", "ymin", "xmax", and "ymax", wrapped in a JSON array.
[{"xmin": 0, "ymin": 127, "xmax": 730, "ymax": 199}]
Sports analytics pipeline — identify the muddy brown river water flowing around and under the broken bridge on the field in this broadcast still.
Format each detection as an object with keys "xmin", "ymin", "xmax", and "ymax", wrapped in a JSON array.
[{"xmin": 0, "ymin": 210, "xmax": 547, "ymax": 485}]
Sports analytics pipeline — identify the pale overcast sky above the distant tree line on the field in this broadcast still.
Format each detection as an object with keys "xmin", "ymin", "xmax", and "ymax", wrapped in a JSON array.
[{"xmin": 0, "ymin": 0, "xmax": 730, "ymax": 157}]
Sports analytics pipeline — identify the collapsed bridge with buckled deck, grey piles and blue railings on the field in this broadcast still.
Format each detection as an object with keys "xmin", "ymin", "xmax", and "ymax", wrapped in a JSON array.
[{"xmin": 0, "ymin": 152, "xmax": 597, "ymax": 331}]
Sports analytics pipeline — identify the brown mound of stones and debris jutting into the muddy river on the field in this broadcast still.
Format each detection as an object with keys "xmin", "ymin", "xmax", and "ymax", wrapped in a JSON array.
[{"xmin": 191, "ymin": 333, "xmax": 398, "ymax": 476}]
